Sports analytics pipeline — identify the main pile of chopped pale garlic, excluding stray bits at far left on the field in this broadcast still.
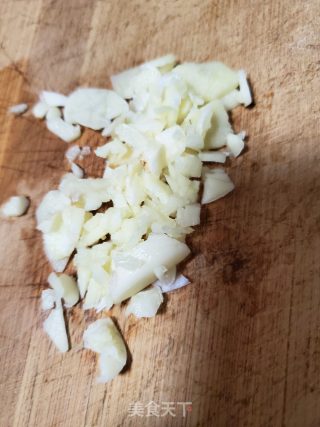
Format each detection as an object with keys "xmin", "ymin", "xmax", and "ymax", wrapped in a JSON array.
[{"xmin": 33, "ymin": 54, "xmax": 252, "ymax": 382}]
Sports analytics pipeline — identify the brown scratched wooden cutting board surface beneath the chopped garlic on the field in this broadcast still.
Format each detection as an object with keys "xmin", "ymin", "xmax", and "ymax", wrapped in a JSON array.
[{"xmin": 0, "ymin": 0, "xmax": 320, "ymax": 427}]
